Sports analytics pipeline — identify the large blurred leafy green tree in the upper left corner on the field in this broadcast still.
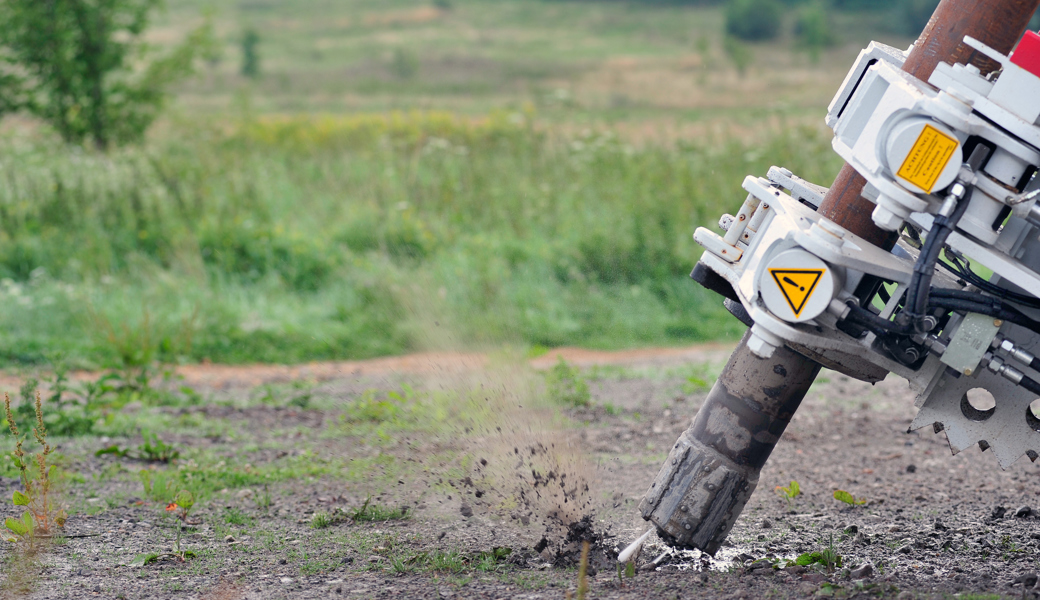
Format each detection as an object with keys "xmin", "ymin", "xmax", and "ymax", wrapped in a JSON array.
[{"xmin": 0, "ymin": 0, "xmax": 211, "ymax": 150}]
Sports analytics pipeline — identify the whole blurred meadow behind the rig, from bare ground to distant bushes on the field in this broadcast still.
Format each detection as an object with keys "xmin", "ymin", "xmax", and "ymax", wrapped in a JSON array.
[{"xmin": 0, "ymin": 0, "xmax": 909, "ymax": 367}]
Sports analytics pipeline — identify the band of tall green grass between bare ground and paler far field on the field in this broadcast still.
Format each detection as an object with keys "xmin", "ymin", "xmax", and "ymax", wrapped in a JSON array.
[{"xmin": 0, "ymin": 113, "xmax": 837, "ymax": 366}]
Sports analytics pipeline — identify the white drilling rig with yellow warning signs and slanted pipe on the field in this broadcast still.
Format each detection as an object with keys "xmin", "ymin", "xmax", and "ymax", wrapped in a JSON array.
[{"xmin": 640, "ymin": 0, "xmax": 1040, "ymax": 555}]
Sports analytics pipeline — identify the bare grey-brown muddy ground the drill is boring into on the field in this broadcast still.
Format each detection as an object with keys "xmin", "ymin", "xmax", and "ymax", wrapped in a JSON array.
[{"xmin": 0, "ymin": 347, "xmax": 1040, "ymax": 599}]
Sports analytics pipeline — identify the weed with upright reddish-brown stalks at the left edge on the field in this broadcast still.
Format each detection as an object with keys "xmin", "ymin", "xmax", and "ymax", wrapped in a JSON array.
[{"xmin": 4, "ymin": 392, "xmax": 66, "ymax": 544}]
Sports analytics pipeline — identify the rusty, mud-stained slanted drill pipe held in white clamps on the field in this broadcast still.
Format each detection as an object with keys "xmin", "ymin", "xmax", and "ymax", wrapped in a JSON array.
[{"xmin": 640, "ymin": 0, "xmax": 1040, "ymax": 555}]
